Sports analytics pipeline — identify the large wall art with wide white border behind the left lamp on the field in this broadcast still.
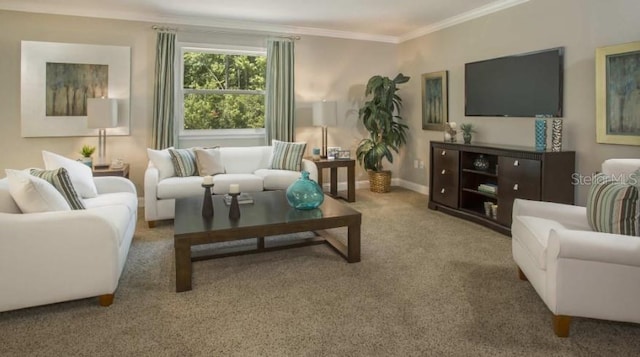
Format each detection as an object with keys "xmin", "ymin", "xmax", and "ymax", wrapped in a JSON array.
[{"xmin": 20, "ymin": 41, "xmax": 131, "ymax": 137}]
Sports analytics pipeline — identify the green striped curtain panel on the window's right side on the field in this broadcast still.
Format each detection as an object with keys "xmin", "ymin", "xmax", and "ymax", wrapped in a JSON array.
[{"xmin": 265, "ymin": 39, "xmax": 295, "ymax": 145}]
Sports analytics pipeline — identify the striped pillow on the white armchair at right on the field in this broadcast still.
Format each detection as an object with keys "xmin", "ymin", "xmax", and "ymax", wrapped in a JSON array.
[{"xmin": 587, "ymin": 173, "xmax": 640, "ymax": 236}]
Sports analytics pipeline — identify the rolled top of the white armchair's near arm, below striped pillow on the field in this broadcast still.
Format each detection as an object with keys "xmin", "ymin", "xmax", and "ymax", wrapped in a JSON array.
[{"xmin": 547, "ymin": 229, "xmax": 640, "ymax": 267}]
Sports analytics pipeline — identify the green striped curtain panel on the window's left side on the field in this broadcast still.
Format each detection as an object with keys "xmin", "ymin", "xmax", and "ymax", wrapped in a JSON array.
[{"xmin": 152, "ymin": 31, "xmax": 176, "ymax": 149}]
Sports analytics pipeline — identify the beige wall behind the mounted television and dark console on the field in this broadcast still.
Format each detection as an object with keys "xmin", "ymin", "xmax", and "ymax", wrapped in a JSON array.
[{"xmin": 398, "ymin": 0, "xmax": 640, "ymax": 204}]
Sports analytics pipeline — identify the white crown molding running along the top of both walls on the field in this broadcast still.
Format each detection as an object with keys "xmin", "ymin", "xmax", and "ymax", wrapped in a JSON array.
[{"xmin": 0, "ymin": 0, "xmax": 529, "ymax": 44}]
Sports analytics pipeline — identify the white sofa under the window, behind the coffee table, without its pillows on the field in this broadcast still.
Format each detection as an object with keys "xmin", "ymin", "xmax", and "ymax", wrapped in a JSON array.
[{"xmin": 144, "ymin": 146, "xmax": 318, "ymax": 227}]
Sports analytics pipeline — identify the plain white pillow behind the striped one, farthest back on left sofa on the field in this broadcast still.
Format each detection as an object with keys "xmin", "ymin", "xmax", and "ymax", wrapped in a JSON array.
[{"xmin": 42, "ymin": 151, "xmax": 98, "ymax": 198}]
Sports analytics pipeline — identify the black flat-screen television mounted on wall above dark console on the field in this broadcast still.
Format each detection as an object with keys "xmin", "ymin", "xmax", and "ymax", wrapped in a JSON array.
[{"xmin": 464, "ymin": 47, "xmax": 564, "ymax": 117}]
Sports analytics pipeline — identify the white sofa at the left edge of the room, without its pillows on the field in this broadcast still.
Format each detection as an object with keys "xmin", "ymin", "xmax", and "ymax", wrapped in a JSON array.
[{"xmin": 0, "ymin": 177, "xmax": 138, "ymax": 311}]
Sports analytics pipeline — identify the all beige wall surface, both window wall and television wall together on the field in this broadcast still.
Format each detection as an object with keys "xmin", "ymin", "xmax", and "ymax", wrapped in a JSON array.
[{"xmin": 0, "ymin": 0, "xmax": 640, "ymax": 203}]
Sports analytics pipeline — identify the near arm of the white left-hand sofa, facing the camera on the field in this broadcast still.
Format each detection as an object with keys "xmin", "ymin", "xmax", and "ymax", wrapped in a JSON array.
[{"xmin": 0, "ymin": 207, "xmax": 122, "ymax": 311}]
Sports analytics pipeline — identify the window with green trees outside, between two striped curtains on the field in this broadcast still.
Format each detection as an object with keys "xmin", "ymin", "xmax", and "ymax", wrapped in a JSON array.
[{"xmin": 177, "ymin": 47, "xmax": 267, "ymax": 136}]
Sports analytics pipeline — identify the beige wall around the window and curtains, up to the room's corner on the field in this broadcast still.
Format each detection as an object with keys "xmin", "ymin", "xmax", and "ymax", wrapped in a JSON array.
[{"xmin": 0, "ymin": 11, "xmax": 396, "ymax": 195}]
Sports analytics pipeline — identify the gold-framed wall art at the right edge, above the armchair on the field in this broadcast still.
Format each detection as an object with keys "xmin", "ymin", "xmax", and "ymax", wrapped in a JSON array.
[{"xmin": 596, "ymin": 42, "xmax": 640, "ymax": 145}]
